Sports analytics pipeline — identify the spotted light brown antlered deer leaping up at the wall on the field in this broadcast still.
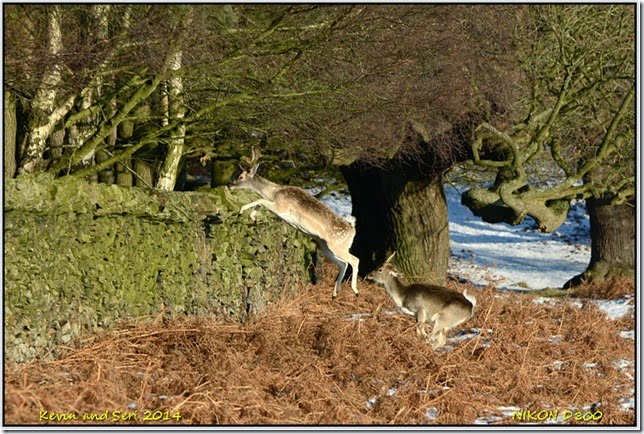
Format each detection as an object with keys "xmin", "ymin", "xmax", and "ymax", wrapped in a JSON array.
[{"xmin": 229, "ymin": 147, "xmax": 360, "ymax": 299}]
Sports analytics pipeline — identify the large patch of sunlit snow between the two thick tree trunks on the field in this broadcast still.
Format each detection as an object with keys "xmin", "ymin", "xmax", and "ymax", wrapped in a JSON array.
[{"xmin": 445, "ymin": 186, "xmax": 590, "ymax": 290}]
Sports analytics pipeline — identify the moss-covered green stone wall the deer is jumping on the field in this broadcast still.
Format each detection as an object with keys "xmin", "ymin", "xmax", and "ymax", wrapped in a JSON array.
[{"xmin": 4, "ymin": 176, "xmax": 314, "ymax": 362}]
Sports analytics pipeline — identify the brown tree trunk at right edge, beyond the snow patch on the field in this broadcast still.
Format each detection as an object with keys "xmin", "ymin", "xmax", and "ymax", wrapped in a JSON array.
[{"xmin": 564, "ymin": 199, "xmax": 635, "ymax": 288}]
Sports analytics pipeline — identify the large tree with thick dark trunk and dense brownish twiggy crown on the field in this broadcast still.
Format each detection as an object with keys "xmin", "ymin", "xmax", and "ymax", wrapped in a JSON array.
[{"xmin": 296, "ymin": 5, "xmax": 523, "ymax": 282}]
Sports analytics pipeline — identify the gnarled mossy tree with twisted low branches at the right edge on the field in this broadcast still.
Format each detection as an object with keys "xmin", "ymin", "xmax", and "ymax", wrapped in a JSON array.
[{"xmin": 462, "ymin": 5, "xmax": 635, "ymax": 285}]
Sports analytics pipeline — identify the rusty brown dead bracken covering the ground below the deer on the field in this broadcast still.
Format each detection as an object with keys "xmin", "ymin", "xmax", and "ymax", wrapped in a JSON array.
[{"xmin": 4, "ymin": 269, "xmax": 635, "ymax": 426}]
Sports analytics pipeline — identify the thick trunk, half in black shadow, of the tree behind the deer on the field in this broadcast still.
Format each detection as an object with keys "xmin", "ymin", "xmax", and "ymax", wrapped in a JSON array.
[{"xmin": 342, "ymin": 160, "xmax": 449, "ymax": 284}]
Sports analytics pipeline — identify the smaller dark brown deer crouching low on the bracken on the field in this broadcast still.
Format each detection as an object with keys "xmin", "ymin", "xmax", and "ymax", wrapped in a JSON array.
[{"xmin": 366, "ymin": 252, "xmax": 476, "ymax": 350}]
